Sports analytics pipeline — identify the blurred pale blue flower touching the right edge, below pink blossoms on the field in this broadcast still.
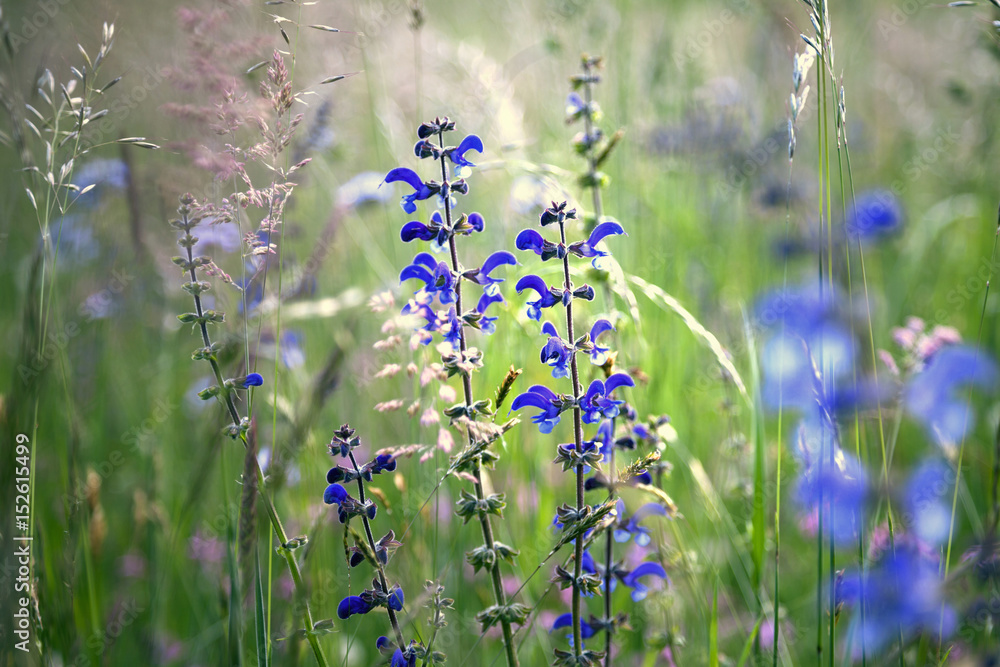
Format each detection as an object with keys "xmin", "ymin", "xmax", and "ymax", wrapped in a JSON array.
[{"xmin": 904, "ymin": 345, "xmax": 997, "ymax": 445}]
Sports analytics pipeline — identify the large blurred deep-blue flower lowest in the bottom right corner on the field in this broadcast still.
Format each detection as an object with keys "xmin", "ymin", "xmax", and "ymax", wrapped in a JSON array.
[{"xmin": 837, "ymin": 543, "xmax": 957, "ymax": 656}]
